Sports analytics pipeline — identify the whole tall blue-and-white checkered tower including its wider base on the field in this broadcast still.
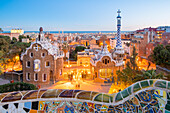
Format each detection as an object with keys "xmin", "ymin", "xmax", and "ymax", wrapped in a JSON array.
[{"xmin": 115, "ymin": 10, "xmax": 124, "ymax": 63}]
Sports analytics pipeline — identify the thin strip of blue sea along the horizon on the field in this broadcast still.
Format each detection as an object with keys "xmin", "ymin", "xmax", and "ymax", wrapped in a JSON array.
[{"xmin": 2, "ymin": 31, "xmax": 131, "ymax": 33}]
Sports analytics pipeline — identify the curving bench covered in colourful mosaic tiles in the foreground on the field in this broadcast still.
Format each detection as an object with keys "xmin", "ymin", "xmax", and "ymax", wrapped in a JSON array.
[{"xmin": 0, "ymin": 79, "xmax": 170, "ymax": 113}]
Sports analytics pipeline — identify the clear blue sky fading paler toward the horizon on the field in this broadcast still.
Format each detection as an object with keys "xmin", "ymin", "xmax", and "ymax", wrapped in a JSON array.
[{"xmin": 0, "ymin": 0, "xmax": 170, "ymax": 31}]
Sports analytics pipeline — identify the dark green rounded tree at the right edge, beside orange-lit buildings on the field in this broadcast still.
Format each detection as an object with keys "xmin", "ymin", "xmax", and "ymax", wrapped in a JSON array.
[{"xmin": 152, "ymin": 45, "xmax": 170, "ymax": 67}]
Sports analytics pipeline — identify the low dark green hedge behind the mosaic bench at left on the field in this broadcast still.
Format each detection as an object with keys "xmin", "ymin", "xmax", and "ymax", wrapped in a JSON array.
[{"xmin": 0, "ymin": 82, "xmax": 37, "ymax": 93}]
